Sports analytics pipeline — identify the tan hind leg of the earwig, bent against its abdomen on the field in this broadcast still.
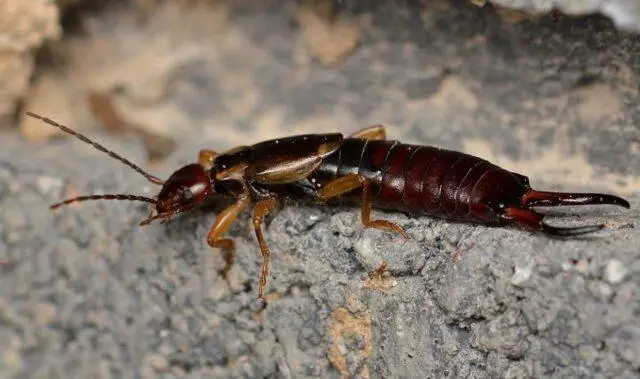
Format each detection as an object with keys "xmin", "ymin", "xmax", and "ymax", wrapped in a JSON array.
[{"xmin": 318, "ymin": 174, "xmax": 409, "ymax": 239}]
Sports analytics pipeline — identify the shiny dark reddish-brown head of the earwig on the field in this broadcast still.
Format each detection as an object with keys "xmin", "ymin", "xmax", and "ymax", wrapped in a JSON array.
[{"xmin": 156, "ymin": 163, "xmax": 213, "ymax": 220}]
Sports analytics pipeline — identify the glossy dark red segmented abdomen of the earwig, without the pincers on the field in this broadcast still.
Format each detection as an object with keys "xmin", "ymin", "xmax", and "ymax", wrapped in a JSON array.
[{"xmin": 313, "ymin": 139, "xmax": 523, "ymax": 222}]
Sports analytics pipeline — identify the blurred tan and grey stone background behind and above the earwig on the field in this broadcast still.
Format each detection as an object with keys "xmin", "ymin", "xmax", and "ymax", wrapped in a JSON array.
[{"xmin": 0, "ymin": 0, "xmax": 640, "ymax": 192}]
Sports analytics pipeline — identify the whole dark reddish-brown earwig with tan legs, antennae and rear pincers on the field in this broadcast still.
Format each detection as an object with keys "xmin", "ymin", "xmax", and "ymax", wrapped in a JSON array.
[{"xmin": 27, "ymin": 112, "xmax": 630, "ymax": 298}]
